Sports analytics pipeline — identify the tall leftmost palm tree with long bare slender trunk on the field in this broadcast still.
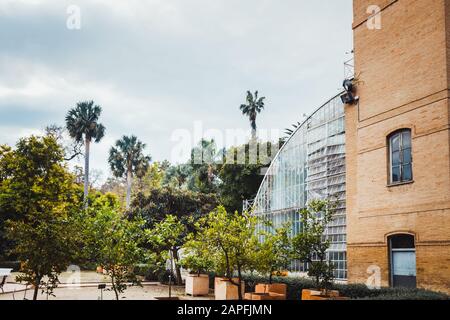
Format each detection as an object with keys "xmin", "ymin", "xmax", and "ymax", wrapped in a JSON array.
[{"xmin": 66, "ymin": 101, "xmax": 105, "ymax": 208}]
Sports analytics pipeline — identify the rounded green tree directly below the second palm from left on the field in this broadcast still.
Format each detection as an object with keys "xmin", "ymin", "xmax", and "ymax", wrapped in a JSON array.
[{"xmin": 82, "ymin": 208, "xmax": 147, "ymax": 300}]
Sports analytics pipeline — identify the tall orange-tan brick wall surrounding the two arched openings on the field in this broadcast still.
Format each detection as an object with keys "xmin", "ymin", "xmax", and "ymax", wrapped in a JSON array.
[{"xmin": 346, "ymin": 0, "xmax": 450, "ymax": 292}]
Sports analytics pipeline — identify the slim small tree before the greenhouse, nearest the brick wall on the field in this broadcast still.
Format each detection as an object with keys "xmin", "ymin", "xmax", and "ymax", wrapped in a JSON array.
[{"xmin": 292, "ymin": 200, "xmax": 336, "ymax": 290}]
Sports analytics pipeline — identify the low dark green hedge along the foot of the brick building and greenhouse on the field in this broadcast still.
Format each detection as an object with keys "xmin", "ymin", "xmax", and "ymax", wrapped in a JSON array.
[{"xmin": 243, "ymin": 275, "xmax": 450, "ymax": 300}]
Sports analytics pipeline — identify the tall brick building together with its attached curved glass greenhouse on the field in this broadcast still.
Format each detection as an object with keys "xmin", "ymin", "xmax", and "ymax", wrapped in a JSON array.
[{"xmin": 252, "ymin": 0, "xmax": 450, "ymax": 292}]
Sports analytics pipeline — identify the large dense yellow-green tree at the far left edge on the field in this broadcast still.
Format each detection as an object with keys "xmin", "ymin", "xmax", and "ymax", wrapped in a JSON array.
[{"xmin": 0, "ymin": 136, "xmax": 81, "ymax": 299}]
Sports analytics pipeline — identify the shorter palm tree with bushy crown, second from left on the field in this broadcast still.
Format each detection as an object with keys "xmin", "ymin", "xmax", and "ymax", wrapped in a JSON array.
[{"xmin": 108, "ymin": 136, "xmax": 151, "ymax": 210}]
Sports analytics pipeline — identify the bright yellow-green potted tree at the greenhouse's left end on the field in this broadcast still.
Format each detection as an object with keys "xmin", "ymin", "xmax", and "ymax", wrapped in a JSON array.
[{"xmin": 194, "ymin": 206, "xmax": 258, "ymax": 300}]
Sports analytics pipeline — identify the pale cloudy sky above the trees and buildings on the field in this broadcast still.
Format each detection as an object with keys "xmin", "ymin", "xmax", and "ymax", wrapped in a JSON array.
[{"xmin": 0, "ymin": 0, "xmax": 352, "ymax": 180}]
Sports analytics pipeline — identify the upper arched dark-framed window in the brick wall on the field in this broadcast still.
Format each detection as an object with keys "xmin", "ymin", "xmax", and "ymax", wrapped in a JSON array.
[{"xmin": 388, "ymin": 129, "xmax": 413, "ymax": 184}]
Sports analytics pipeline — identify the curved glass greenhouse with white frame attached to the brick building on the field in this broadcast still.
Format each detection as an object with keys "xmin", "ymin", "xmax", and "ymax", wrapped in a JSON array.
[{"xmin": 253, "ymin": 96, "xmax": 347, "ymax": 280}]
